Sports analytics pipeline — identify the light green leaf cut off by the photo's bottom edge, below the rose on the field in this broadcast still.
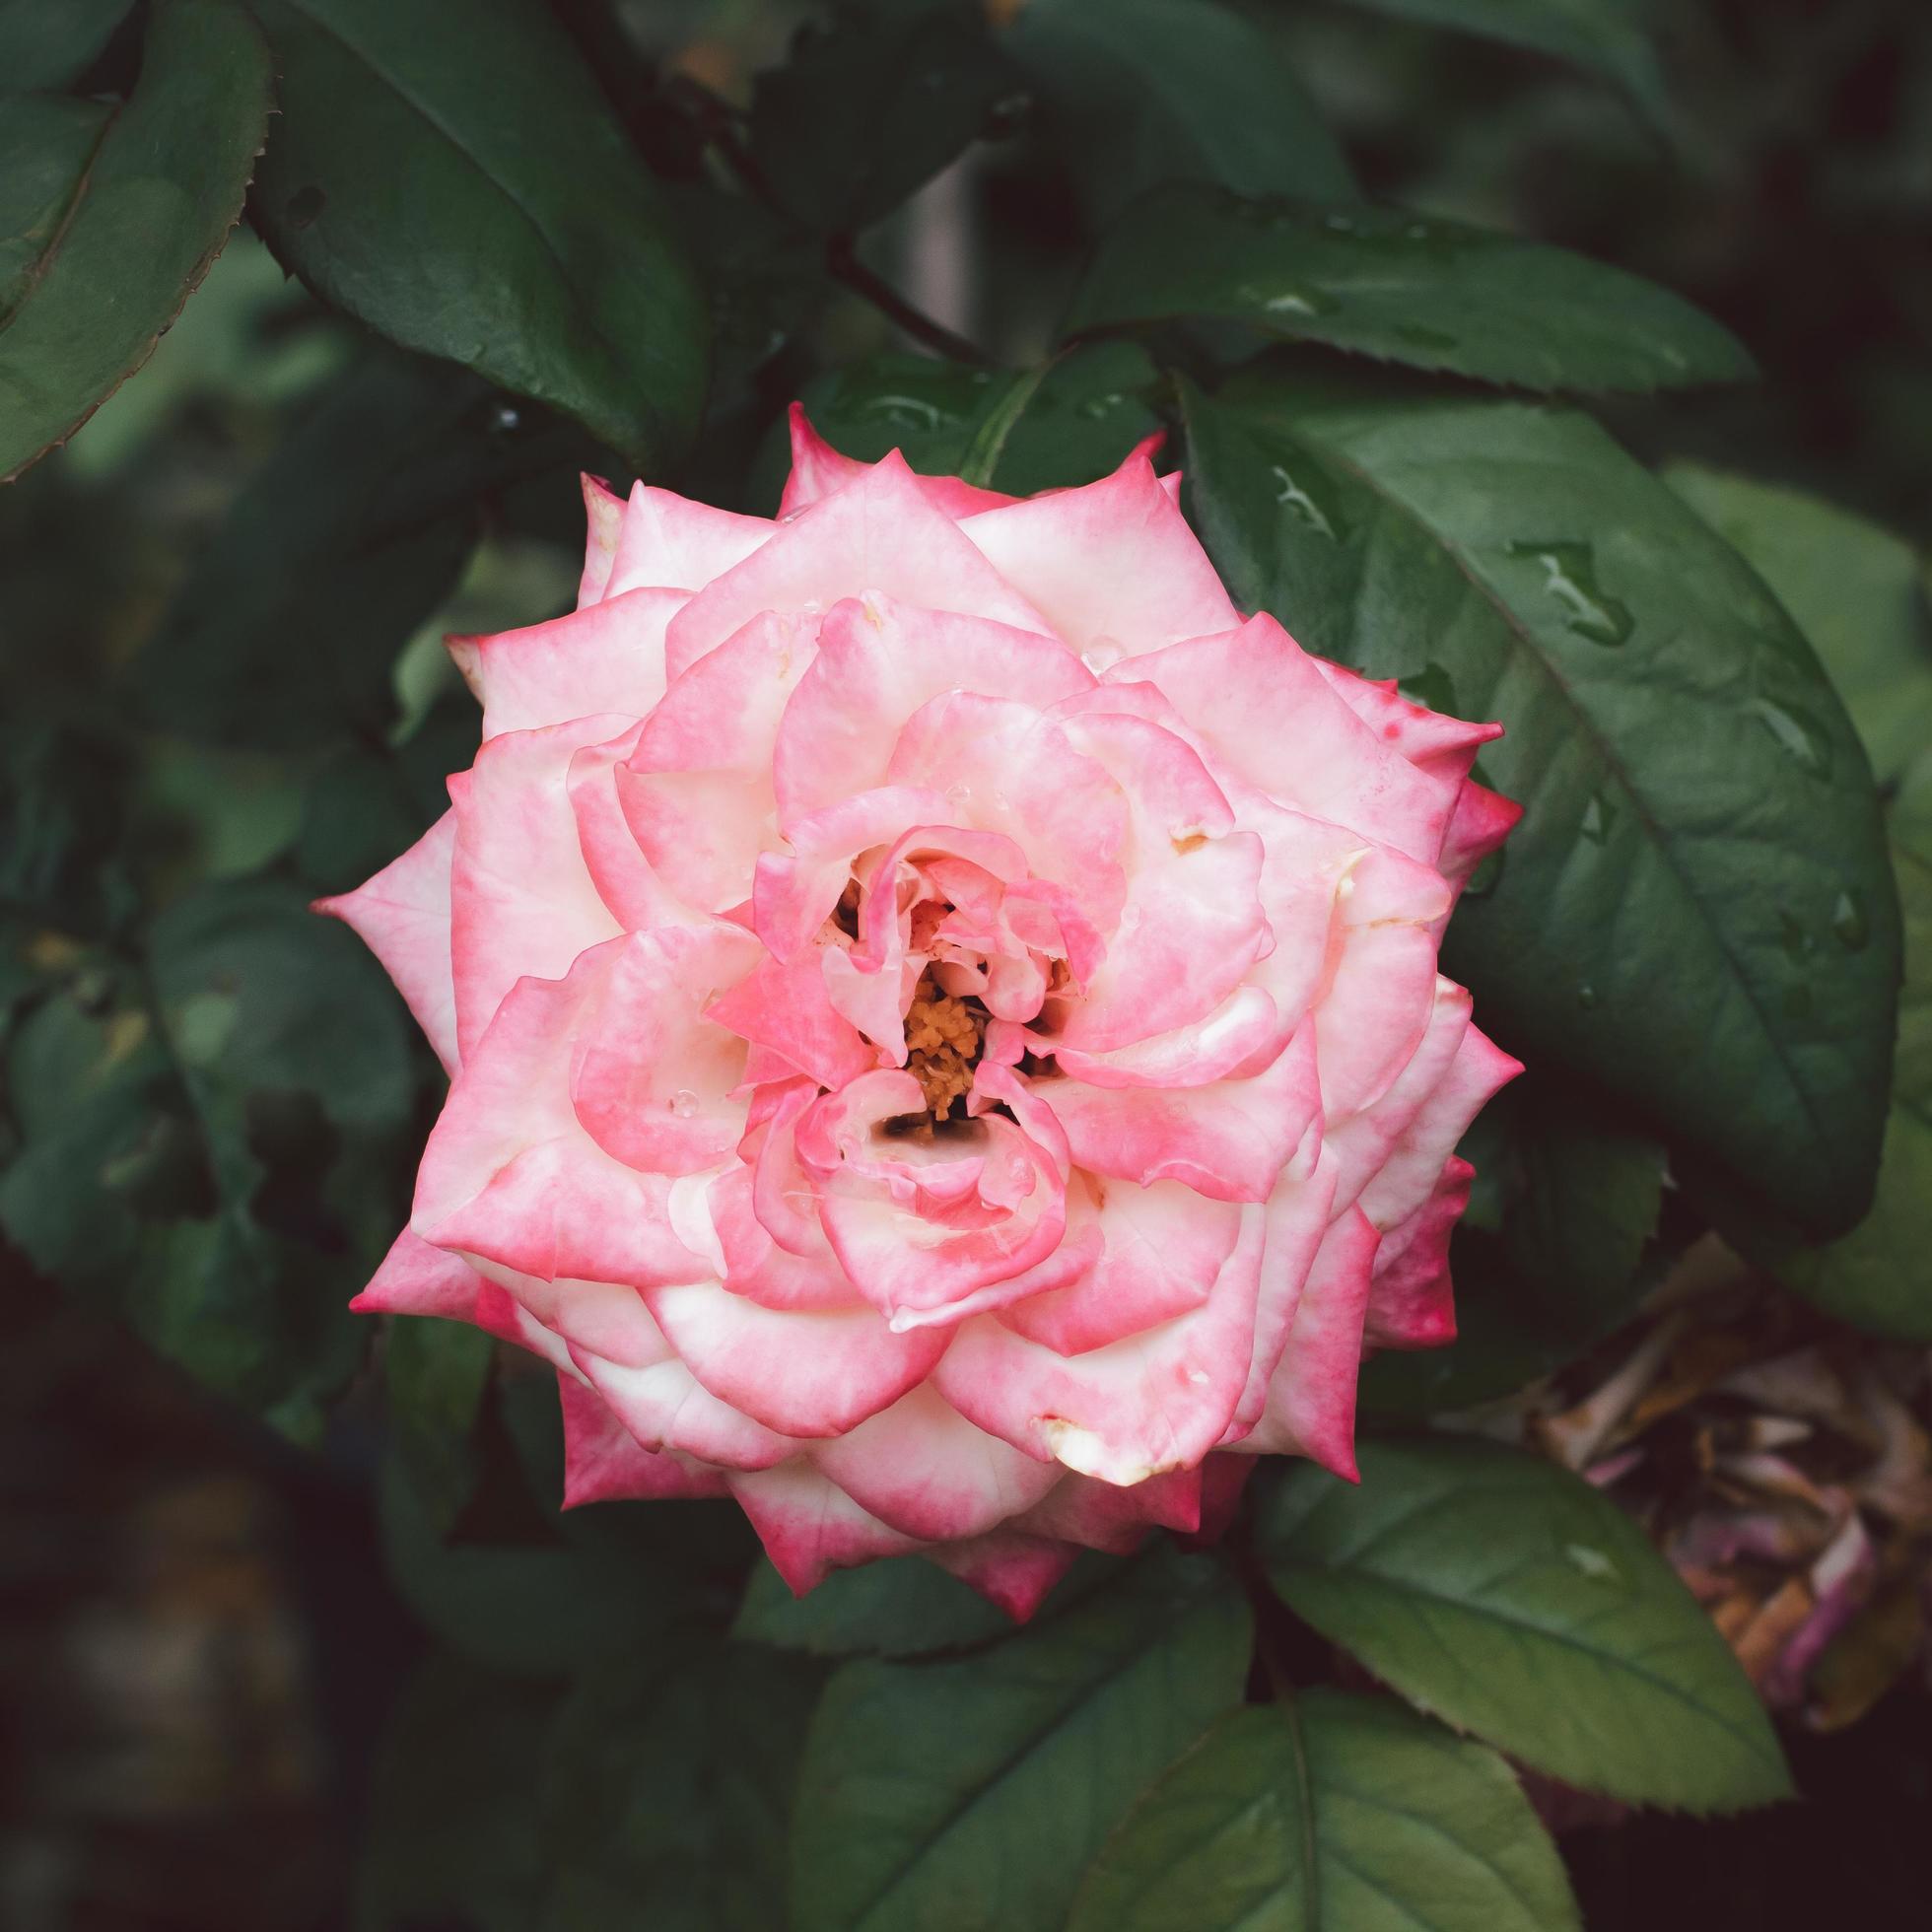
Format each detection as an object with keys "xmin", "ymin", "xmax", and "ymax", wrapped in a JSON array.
[{"xmin": 1069, "ymin": 1689, "xmax": 1582, "ymax": 1932}]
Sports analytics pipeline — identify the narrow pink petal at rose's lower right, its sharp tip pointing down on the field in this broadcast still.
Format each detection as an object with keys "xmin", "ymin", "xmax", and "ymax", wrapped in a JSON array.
[{"xmin": 1229, "ymin": 1208, "xmax": 1381, "ymax": 1482}]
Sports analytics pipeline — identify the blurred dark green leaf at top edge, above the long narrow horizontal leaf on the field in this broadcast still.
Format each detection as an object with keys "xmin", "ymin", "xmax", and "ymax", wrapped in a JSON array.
[{"xmin": 1008, "ymin": 0, "xmax": 1354, "ymax": 222}]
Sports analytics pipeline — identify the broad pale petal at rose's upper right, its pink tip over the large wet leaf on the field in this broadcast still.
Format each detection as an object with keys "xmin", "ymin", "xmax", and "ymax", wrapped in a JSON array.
[{"xmin": 1105, "ymin": 616, "xmax": 1457, "ymax": 863}]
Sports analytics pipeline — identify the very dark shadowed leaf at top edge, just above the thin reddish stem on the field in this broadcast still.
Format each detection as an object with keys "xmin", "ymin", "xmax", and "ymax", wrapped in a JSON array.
[{"xmin": 751, "ymin": 0, "xmax": 1020, "ymax": 234}]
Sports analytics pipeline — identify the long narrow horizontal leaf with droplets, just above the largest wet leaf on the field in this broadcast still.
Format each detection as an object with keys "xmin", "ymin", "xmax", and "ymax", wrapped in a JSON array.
[{"xmin": 1067, "ymin": 187, "xmax": 1753, "ymax": 390}]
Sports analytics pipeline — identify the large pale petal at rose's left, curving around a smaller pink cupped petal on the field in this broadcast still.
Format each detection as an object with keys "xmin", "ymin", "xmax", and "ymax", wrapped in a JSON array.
[{"xmin": 410, "ymin": 946, "xmax": 705, "ymax": 1286}]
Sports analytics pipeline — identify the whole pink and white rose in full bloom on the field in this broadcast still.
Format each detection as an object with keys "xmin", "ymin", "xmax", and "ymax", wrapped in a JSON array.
[{"xmin": 322, "ymin": 410, "xmax": 1519, "ymax": 1616}]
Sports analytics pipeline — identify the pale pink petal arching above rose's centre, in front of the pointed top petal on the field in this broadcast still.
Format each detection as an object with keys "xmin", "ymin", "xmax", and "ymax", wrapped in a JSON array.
[{"xmin": 775, "ymin": 595, "xmax": 1093, "ymax": 825}]
